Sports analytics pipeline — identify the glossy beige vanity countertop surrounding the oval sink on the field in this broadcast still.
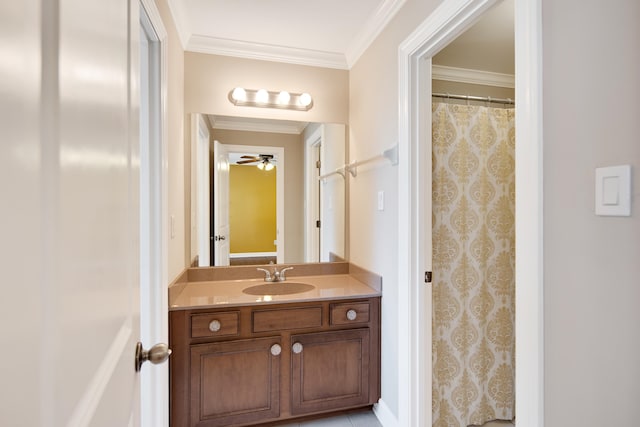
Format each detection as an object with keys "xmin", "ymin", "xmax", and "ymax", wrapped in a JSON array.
[{"xmin": 169, "ymin": 274, "xmax": 380, "ymax": 310}]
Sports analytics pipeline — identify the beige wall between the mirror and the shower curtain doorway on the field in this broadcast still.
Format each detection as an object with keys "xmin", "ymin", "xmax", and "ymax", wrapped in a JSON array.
[{"xmin": 349, "ymin": 0, "xmax": 440, "ymax": 416}]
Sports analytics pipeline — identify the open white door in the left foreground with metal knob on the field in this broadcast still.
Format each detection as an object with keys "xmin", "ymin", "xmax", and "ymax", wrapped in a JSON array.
[{"xmin": 0, "ymin": 0, "xmax": 168, "ymax": 427}]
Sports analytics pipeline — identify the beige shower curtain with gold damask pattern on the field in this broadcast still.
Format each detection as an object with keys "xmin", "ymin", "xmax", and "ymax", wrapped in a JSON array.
[{"xmin": 432, "ymin": 103, "xmax": 515, "ymax": 427}]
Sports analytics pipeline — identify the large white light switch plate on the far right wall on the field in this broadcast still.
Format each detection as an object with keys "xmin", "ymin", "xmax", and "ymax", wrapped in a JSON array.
[{"xmin": 595, "ymin": 165, "xmax": 631, "ymax": 216}]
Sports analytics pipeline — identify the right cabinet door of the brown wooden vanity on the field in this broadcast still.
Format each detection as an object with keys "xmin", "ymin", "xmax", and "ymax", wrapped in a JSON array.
[{"xmin": 291, "ymin": 329, "xmax": 370, "ymax": 414}]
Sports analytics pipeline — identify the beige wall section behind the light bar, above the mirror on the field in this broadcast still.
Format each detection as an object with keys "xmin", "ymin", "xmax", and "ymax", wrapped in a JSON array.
[{"xmin": 185, "ymin": 52, "xmax": 349, "ymax": 123}]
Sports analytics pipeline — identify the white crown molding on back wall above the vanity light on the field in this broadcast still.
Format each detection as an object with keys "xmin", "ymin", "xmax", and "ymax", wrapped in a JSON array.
[{"xmin": 185, "ymin": 34, "xmax": 348, "ymax": 70}]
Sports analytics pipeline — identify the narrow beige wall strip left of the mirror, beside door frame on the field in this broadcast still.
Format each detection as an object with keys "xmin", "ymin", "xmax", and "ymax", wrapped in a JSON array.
[{"xmin": 156, "ymin": 0, "xmax": 190, "ymax": 281}]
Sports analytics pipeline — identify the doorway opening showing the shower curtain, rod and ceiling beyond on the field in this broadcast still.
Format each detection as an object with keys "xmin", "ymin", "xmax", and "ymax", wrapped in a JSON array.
[{"xmin": 430, "ymin": 0, "xmax": 517, "ymax": 427}]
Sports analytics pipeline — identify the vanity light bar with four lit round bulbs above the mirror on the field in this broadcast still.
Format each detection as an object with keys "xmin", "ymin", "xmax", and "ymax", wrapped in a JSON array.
[{"xmin": 228, "ymin": 87, "xmax": 313, "ymax": 111}]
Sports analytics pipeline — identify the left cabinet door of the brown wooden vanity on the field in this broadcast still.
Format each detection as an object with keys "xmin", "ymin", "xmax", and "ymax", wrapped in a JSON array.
[{"xmin": 190, "ymin": 337, "xmax": 281, "ymax": 427}]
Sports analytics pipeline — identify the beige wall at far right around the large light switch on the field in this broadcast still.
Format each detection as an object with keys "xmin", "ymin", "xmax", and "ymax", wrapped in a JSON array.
[{"xmin": 540, "ymin": 0, "xmax": 640, "ymax": 427}]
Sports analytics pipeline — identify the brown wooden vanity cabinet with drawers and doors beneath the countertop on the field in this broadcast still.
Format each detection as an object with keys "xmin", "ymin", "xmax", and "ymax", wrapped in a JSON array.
[{"xmin": 169, "ymin": 298, "xmax": 380, "ymax": 427}]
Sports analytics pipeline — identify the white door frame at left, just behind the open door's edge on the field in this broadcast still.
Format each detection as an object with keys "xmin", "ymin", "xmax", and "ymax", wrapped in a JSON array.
[{"xmin": 139, "ymin": 0, "xmax": 169, "ymax": 427}]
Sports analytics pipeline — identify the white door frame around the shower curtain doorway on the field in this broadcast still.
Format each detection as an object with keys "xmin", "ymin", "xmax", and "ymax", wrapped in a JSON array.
[{"xmin": 398, "ymin": 0, "xmax": 544, "ymax": 427}]
